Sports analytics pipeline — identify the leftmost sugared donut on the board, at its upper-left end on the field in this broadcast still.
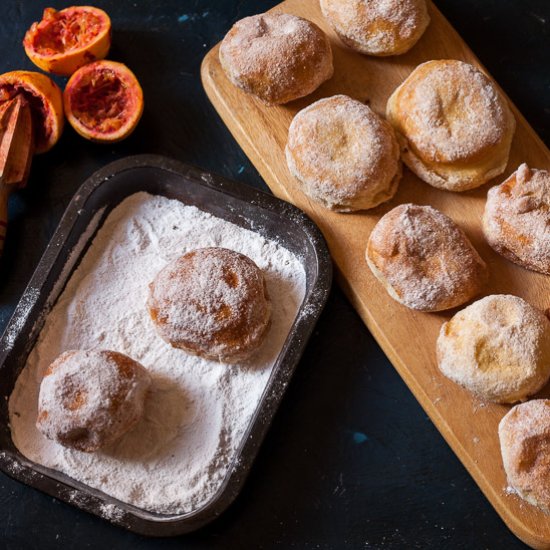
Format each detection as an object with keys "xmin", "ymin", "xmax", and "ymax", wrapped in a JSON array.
[{"xmin": 220, "ymin": 13, "xmax": 334, "ymax": 105}]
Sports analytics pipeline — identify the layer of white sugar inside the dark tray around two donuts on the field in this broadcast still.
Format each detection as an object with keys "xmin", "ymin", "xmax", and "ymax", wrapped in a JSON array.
[{"xmin": 9, "ymin": 193, "xmax": 305, "ymax": 513}]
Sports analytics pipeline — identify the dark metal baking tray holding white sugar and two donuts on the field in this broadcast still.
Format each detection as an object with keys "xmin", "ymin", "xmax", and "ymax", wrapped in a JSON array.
[{"xmin": 0, "ymin": 155, "xmax": 332, "ymax": 536}]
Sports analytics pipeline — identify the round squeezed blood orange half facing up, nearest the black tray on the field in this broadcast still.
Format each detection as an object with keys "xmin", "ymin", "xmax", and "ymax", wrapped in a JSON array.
[{"xmin": 63, "ymin": 60, "xmax": 143, "ymax": 143}]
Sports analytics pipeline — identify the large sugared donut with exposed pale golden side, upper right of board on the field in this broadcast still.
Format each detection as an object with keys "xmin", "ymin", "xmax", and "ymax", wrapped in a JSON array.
[{"xmin": 386, "ymin": 59, "xmax": 516, "ymax": 191}]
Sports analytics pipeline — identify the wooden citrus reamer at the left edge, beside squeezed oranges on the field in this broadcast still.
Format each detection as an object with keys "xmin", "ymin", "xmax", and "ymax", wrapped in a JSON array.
[{"xmin": 0, "ymin": 94, "xmax": 34, "ymax": 254}]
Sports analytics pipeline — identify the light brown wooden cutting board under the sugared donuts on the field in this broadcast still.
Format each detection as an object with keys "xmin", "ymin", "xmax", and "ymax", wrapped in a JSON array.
[{"xmin": 202, "ymin": 0, "xmax": 550, "ymax": 548}]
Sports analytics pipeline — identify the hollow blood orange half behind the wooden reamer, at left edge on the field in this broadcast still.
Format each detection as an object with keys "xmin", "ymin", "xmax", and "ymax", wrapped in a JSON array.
[{"xmin": 0, "ymin": 71, "xmax": 65, "ymax": 153}]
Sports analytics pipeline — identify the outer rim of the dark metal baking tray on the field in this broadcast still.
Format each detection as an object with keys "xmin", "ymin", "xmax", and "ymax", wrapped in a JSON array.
[{"xmin": 0, "ymin": 154, "xmax": 332, "ymax": 536}]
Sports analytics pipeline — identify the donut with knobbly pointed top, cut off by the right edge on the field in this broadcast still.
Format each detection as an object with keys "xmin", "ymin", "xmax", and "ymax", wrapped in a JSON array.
[{"xmin": 483, "ymin": 164, "xmax": 550, "ymax": 275}]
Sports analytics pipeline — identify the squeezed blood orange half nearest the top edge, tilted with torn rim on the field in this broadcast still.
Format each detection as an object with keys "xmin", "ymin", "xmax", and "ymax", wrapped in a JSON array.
[{"xmin": 23, "ymin": 6, "xmax": 111, "ymax": 76}]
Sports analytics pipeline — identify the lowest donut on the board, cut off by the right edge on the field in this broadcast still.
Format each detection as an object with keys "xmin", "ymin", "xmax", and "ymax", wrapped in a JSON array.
[{"xmin": 498, "ymin": 399, "xmax": 550, "ymax": 513}]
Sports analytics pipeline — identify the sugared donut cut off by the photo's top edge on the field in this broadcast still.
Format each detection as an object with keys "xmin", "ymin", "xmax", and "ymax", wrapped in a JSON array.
[{"xmin": 321, "ymin": 0, "xmax": 430, "ymax": 56}]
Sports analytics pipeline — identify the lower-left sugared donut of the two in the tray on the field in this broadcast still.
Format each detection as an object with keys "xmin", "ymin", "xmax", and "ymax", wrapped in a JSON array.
[{"xmin": 36, "ymin": 350, "xmax": 151, "ymax": 453}]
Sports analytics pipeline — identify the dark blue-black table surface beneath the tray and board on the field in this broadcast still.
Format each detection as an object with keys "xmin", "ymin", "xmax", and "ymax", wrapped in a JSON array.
[{"xmin": 0, "ymin": 0, "xmax": 550, "ymax": 550}]
